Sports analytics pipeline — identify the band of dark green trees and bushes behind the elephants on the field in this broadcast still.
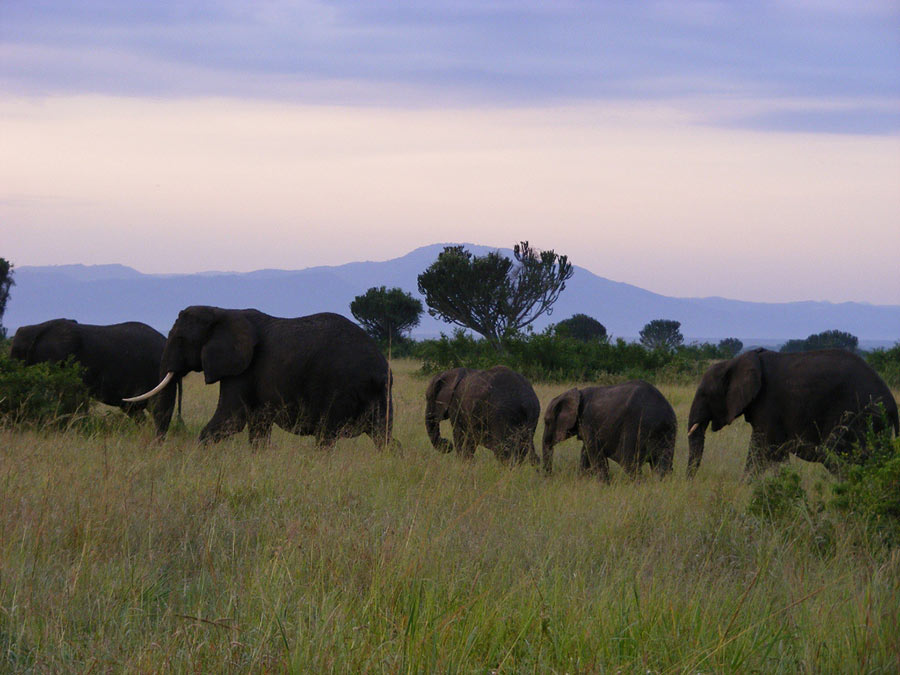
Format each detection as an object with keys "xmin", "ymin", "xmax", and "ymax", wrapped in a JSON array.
[{"xmin": 351, "ymin": 242, "xmax": 900, "ymax": 387}]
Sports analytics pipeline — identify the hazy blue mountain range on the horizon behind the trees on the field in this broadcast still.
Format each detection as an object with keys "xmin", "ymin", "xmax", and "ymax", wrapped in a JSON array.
[{"xmin": 4, "ymin": 244, "xmax": 900, "ymax": 347}]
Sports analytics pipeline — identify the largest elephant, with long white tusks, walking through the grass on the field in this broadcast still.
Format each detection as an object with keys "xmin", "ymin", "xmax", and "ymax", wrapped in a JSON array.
[{"xmin": 127, "ymin": 305, "xmax": 394, "ymax": 449}]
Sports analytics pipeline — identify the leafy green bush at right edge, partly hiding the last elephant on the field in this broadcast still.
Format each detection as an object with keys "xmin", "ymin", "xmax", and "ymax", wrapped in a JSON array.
[{"xmin": 830, "ymin": 423, "xmax": 900, "ymax": 545}]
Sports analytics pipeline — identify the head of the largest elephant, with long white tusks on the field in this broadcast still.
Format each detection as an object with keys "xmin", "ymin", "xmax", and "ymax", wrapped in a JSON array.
[{"xmin": 126, "ymin": 306, "xmax": 258, "ymax": 401}]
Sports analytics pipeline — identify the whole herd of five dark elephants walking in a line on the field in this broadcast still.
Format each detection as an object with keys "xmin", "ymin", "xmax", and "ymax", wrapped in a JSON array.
[{"xmin": 10, "ymin": 306, "xmax": 900, "ymax": 480}]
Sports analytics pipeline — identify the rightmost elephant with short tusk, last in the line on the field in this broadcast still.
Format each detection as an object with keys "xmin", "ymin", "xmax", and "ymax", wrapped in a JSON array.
[{"xmin": 688, "ymin": 349, "xmax": 900, "ymax": 477}]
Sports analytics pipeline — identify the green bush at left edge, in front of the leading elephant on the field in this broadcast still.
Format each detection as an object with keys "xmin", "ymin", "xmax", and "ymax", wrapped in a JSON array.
[{"xmin": 0, "ymin": 354, "xmax": 90, "ymax": 425}]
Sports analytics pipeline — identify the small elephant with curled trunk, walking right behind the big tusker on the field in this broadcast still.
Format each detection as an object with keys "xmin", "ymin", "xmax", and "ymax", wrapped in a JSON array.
[{"xmin": 425, "ymin": 366, "xmax": 541, "ymax": 465}]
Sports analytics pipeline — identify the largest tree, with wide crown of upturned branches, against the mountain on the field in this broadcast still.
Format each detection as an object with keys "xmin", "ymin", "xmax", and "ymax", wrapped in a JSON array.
[{"xmin": 419, "ymin": 241, "xmax": 574, "ymax": 348}]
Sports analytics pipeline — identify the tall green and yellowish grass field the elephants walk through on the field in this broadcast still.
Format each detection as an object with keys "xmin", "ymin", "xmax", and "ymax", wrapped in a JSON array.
[{"xmin": 0, "ymin": 362, "xmax": 900, "ymax": 673}]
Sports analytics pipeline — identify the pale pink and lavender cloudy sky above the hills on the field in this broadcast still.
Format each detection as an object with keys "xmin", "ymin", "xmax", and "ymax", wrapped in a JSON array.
[{"xmin": 0, "ymin": 0, "xmax": 900, "ymax": 304}]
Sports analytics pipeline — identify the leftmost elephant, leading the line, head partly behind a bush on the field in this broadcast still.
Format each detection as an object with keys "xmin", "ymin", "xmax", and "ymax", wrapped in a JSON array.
[{"xmin": 10, "ymin": 319, "xmax": 181, "ymax": 437}]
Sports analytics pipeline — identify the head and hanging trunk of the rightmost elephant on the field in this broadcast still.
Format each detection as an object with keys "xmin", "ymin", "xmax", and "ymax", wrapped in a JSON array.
[{"xmin": 688, "ymin": 349, "xmax": 762, "ymax": 476}]
